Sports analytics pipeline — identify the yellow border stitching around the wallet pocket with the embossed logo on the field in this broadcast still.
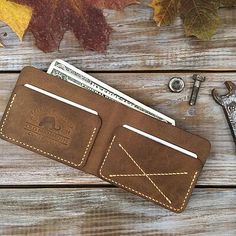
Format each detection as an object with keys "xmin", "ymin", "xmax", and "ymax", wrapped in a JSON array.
[{"xmin": 0, "ymin": 94, "xmax": 97, "ymax": 167}]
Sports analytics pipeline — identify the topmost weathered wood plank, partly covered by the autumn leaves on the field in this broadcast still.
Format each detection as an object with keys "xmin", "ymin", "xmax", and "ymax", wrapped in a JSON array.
[{"xmin": 0, "ymin": 0, "xmax": 236, "ymax": 71}]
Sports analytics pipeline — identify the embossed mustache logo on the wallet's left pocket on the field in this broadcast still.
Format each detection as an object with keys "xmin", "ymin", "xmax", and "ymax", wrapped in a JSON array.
[{"xmin": 24, "ymin": 108, "xmax": 74, "ymax": 146}]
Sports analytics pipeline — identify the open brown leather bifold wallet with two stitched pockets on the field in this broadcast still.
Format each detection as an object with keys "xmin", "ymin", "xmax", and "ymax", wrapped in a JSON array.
[{"xmin": 0, "ymin": 67, "xmax": 210, "ymax": 212}]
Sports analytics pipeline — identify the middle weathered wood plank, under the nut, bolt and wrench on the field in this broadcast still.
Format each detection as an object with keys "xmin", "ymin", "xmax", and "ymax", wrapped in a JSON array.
[{"xmin": 0, "ymin": 73, "xmax": 236, "ymax": 186}]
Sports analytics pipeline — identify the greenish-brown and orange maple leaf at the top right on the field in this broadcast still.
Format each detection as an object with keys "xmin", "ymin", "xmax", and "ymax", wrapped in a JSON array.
[{"xmin": 150, "ymin": 0, "xmax": 236, "ymax": 40}]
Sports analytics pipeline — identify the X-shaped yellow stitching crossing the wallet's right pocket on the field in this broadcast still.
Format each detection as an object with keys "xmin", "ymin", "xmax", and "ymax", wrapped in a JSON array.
[{"xmin": 109, "ymin": 144, "xmax": 188, "ymax": 204}]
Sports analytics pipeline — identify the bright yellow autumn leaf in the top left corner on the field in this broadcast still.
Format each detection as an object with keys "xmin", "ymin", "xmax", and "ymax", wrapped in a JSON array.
[{"xmin": 0, "ymin": 0, "xmax": 32, "ymax": 46}]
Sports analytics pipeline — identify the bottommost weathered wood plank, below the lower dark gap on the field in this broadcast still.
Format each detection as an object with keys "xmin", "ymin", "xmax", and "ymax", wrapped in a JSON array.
[{"xmin": 0, "ymin": 188, "xmax": 236, "ymax": 236}]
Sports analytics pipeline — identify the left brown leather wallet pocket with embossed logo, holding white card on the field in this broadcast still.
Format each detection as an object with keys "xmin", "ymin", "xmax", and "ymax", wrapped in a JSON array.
[{"xmin": 0, "ymin": 85, "xmax": 101, "ymax": 168}]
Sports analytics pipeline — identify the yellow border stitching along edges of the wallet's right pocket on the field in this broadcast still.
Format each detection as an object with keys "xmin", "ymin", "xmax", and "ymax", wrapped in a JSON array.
[{"xmin": 99, "ymin": 136, "xmax": 198, "ymax": 212}]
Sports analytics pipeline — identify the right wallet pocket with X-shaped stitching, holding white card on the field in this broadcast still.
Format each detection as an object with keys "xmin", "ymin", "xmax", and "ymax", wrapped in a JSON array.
[{"xmin": 99, "ymin": 125, "xmax": 205, "ymax": 212}]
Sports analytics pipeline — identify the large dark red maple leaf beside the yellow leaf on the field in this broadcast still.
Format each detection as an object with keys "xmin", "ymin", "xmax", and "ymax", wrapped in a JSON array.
[{"xmin": 12, "ymin": 0, "xmax": 136, "ymax": 52}]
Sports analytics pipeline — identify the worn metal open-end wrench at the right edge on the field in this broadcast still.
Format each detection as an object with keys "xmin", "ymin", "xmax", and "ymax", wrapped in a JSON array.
[{"xmin": 212, "ymin": 81, "xmax": 236, "ymax": 144}]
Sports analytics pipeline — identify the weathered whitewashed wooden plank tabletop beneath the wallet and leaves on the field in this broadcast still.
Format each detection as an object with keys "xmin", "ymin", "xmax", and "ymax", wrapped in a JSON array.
[{"xmin": 0, "ymin": 1, "xmax": 236, "ymax": 236}]
